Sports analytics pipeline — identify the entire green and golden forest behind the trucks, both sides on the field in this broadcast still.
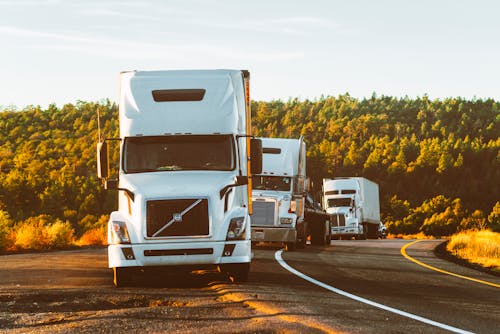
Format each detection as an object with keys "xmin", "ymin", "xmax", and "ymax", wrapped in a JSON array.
[{"xmin": 0, "ymin": 94, "xmax": 500, "ymax": 250}]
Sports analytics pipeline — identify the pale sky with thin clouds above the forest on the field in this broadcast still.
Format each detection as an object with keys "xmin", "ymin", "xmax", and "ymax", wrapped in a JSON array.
[{"xmin": 0, "ymin": 0, "xmax": 500, "ymax": 109}]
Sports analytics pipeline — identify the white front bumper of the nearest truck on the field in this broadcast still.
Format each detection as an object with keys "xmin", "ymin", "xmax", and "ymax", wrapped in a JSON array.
[{"xmin": 108, "ymin": 240, "xmax": 252, "ymax": 268}]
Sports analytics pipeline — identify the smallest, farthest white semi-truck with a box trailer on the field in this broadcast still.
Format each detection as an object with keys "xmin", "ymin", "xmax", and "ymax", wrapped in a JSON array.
[{"xmin": 323, "ymin": 177, "xmax": 380, "ymax": 239}]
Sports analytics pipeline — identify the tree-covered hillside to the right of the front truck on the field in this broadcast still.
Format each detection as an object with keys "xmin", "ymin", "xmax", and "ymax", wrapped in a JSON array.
[{"xmin": 252, "ymin": 94, "xmax": 500, "ymax": 236}]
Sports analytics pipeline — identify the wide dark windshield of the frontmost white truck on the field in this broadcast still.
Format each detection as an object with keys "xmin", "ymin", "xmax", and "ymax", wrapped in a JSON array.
[{"xmin": 123, "ymin": 135, "xmax": 235, "ymax": 173}]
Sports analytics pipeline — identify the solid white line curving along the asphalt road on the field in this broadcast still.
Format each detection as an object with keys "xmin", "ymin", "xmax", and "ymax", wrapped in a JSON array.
[{"xmin": 274, "ymin": 249, "xmax": 472, "ymax": 334}]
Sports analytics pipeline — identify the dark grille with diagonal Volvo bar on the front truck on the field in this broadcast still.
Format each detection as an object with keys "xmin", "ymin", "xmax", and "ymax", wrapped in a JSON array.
[{"xmin": 146, "ymin": 198, "xmax": 210, "ymax": 238}]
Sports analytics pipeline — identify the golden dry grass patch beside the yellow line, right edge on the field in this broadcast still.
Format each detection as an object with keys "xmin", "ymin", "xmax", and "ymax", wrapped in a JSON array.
[{"xmin": 446, "ymin": 230, "xmax": 500, "ymax": 271}]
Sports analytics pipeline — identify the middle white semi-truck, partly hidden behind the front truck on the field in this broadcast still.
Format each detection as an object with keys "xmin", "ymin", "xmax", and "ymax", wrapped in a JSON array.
[{"xmin": 252, "ymin": 137, "xmax": 330, "ymax": 250}]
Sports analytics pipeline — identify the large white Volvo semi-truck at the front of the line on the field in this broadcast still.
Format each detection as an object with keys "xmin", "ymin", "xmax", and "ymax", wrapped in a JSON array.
[{"xmin": 97, "ymin": 70, "xmax": 262, "ymax": 286}]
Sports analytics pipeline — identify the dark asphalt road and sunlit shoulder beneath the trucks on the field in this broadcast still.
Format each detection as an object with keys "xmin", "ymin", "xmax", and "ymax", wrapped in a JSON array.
[{"xmin": 0, "ymin": 240, "xmax": 500, "ymax": 333}]
